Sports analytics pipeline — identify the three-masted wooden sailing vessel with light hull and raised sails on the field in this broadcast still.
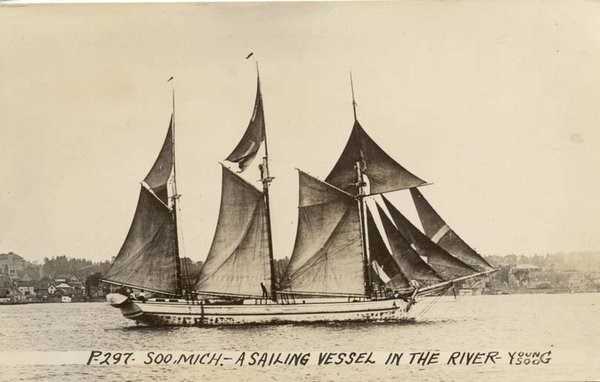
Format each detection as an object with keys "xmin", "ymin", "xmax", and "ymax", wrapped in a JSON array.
[{"xmin": 103, "ymin": 71, "xmax": 494, "ymax": 326}]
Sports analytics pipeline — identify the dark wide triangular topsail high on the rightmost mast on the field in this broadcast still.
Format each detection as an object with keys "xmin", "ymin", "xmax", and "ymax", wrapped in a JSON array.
[{"xmin": 325, "ymin": 121, "xmax": 426, "ymax": 195}]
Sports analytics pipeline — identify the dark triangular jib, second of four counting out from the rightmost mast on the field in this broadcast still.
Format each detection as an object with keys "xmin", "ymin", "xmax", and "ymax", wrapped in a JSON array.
[{"xmin": 378, "ymin": 206, "xmax": 443, "ymax": 284}]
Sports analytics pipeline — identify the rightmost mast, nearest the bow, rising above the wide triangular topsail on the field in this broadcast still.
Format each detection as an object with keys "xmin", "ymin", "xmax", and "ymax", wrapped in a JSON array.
[{"xmin": 350, "ymin": 72, "xmax": 372, "ymax": 297}]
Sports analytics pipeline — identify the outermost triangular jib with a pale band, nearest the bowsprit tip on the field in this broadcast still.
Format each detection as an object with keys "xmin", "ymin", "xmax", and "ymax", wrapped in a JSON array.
[{"xmin": 410, "ymin": 188, "xmax": 494, "ymax": 272}]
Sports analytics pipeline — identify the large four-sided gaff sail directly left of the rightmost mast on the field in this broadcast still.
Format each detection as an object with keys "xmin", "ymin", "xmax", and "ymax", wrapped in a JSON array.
[{"xmin": 282, "ymin": 171, "xmax": 365, "ymax": 295}]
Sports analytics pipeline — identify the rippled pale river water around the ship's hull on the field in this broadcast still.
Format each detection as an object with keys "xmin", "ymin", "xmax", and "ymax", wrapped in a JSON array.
[{"xmin": 0, "ymin": 294, "xmax": 600, "ymax": 381}]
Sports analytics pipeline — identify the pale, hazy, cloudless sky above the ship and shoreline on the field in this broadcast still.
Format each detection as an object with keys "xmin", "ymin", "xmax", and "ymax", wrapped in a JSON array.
[{"xmin": 0, "ymin": 1, "xmax": 600, "ymax": 262}]
